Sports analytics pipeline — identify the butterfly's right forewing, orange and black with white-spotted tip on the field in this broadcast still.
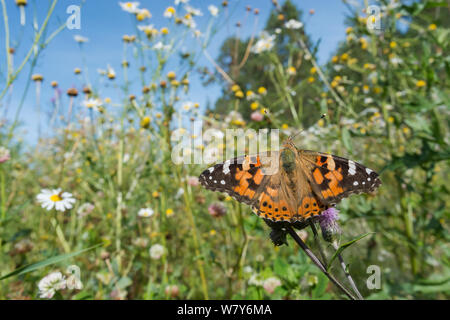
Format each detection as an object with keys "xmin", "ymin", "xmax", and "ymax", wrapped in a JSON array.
[{"xmin": 299, "ymin": 150, "xmax": 381, "ymax": 205}]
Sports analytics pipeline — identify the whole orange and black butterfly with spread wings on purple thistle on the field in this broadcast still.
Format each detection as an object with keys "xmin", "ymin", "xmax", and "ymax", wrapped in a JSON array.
[{"xmin": 199, "ymin": 139, "xmax": 381, "ymax": 224}]
